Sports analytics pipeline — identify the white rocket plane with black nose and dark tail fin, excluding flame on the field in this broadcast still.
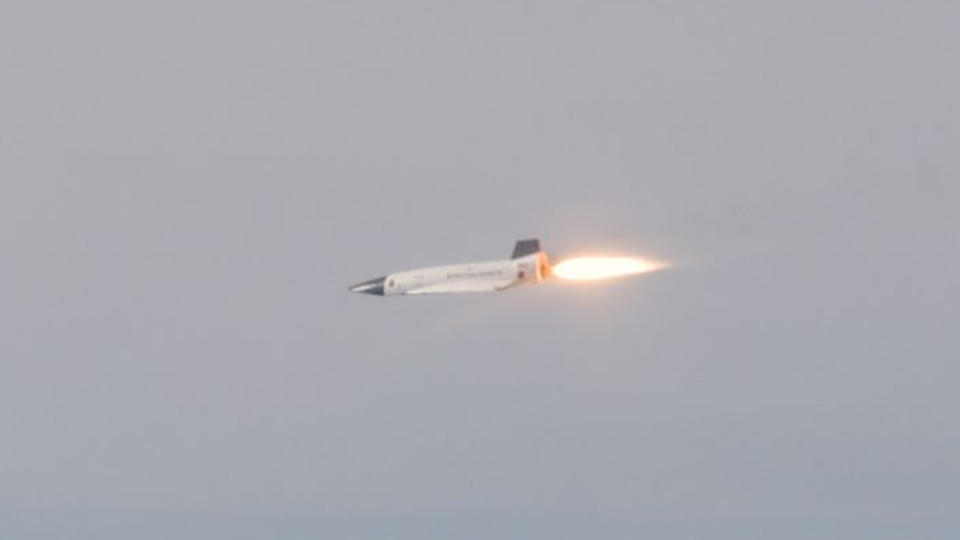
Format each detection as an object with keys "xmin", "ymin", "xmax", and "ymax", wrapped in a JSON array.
[{"xmin": 349, "ymin": 238, "xmax": 551, "ymax": 296}]
